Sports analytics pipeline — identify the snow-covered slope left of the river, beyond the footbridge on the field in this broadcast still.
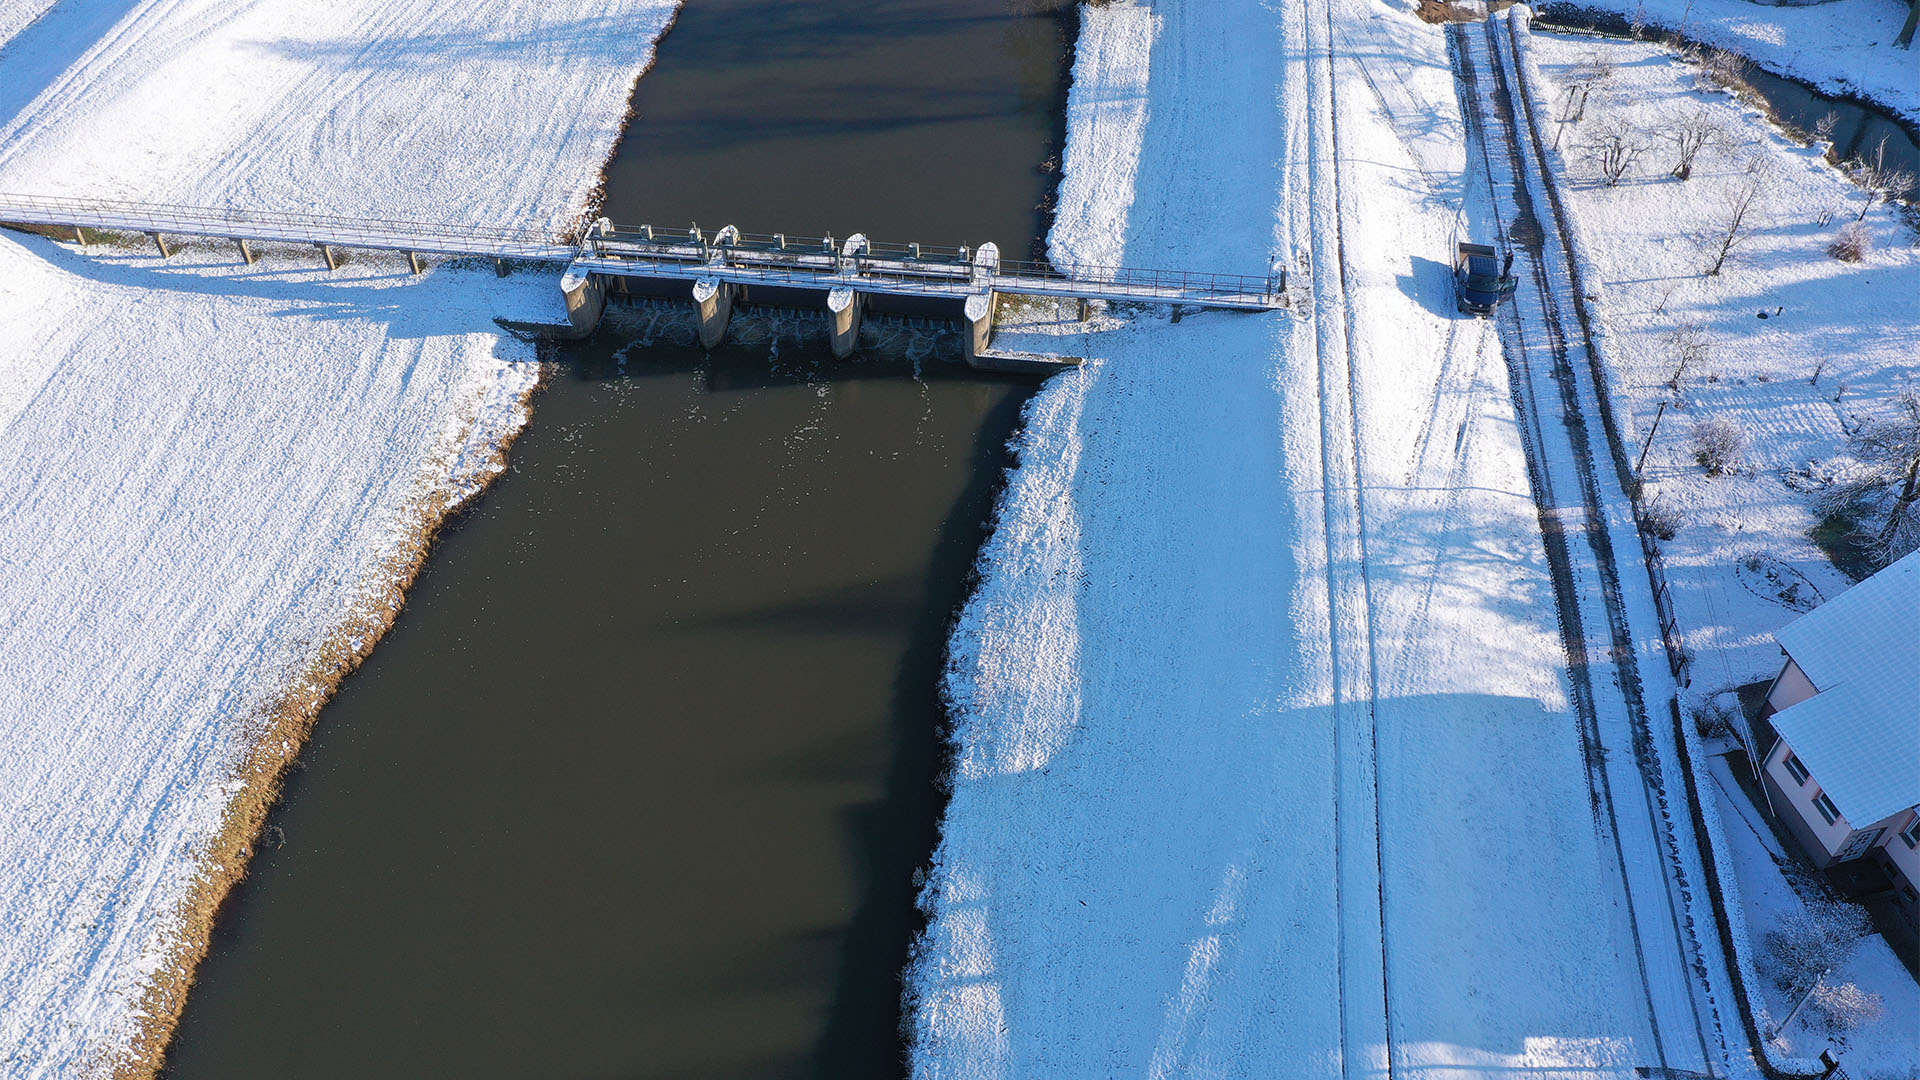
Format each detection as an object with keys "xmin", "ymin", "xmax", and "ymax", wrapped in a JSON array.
[{"xmin": 0, "ymin": 0, "xmax": 678, "ymax": 227}]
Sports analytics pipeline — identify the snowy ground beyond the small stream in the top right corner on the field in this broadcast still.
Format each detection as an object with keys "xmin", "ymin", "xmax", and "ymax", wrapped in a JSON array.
[{"xmin": 1540, "ymin": 0, "xmax": 1920, "ymax": 123}]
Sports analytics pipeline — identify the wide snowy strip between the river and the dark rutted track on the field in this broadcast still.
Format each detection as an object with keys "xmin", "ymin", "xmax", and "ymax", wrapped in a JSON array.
[{"xmin": 908, "ymin": 0, "xmax": 1740, "ymax": 1078}]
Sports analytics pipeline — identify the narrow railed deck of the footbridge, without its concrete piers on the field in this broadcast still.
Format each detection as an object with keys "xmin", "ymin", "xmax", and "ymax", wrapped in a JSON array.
[{"xmin": 0, "ymin": 194, "xmax": 1284, "ymax": 311}]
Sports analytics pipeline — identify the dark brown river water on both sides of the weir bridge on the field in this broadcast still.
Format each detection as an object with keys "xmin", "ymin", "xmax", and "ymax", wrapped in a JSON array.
[{"xmin": 165, "ymin": 0, "xmax": 1071, "ymax": 1080}]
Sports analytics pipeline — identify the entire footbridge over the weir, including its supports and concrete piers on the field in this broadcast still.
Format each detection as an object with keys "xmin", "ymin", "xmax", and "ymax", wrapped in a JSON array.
[{"xmin": 0, "ymin": 194, "xmax": 1286, "ymax": 369}]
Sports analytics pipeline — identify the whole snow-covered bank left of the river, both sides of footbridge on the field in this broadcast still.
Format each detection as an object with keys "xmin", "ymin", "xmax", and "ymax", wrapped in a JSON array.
[{"xmin": 0, "ymin": 0, "xmax": 676, "ymax": 1076}]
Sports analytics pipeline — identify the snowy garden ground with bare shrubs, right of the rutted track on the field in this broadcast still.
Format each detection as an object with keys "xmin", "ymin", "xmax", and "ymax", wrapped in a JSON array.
[{"xmin": 1536, "ymin": 23, "xmax": 1920, "ymax": 1076}]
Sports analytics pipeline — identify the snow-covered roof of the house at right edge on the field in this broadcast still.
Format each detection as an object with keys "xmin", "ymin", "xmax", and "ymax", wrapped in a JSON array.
[{"xmin": 1772, "ymin": 552, "xmax": 1920, "ymax": 828}]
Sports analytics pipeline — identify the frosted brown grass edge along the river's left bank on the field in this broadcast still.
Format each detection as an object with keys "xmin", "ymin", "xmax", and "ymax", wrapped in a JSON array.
[{"xmin": 103, "ymin": 2, "xmax": 684, "ymax": 1060}]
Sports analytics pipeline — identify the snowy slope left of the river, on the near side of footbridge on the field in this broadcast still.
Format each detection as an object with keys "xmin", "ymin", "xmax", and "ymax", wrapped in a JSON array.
[{"xmin": 0, "ymin": 234, "xmax": 551, "ymax": 1076}]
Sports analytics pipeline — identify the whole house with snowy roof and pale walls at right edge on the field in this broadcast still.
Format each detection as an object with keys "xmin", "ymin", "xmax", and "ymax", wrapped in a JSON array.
[{"xmin": 1761, "ymin": 552, "xmax": 1920, "ymax": 922}]
